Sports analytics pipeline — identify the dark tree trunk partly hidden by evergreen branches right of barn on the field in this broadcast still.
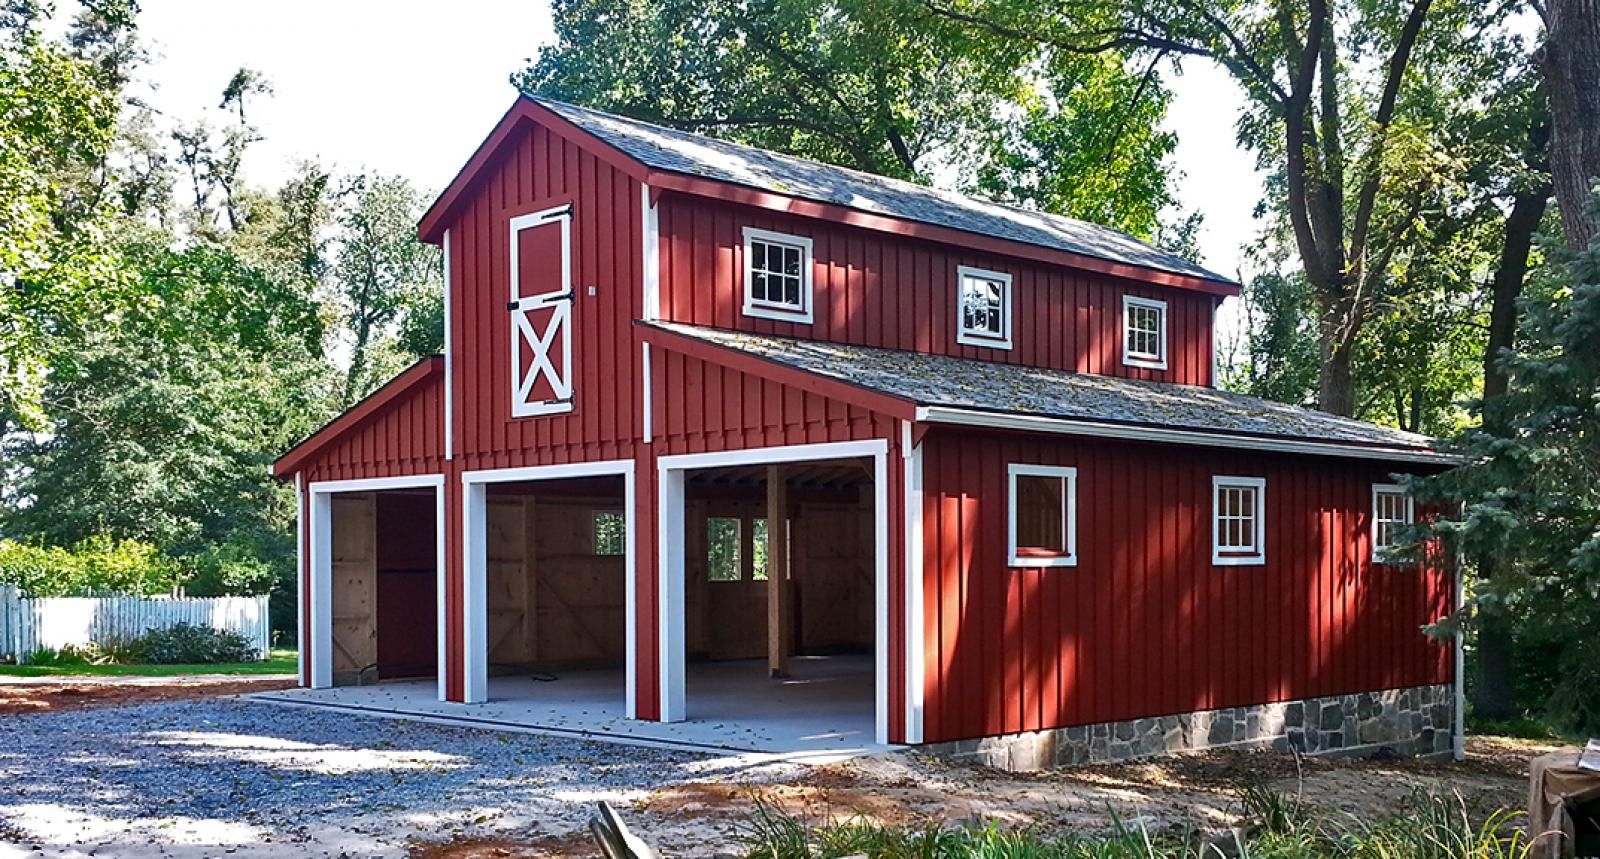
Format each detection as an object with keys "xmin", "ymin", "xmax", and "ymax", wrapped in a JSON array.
[{"xmin": 1472, "ymin": 186, "xmax": 1550, "ymax": 720}]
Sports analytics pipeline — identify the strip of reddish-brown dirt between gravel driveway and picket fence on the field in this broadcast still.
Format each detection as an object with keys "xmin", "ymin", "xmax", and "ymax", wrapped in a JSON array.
[{"xmin": 0, "ymin": 677, "xmax": 294, "ymax": 715}]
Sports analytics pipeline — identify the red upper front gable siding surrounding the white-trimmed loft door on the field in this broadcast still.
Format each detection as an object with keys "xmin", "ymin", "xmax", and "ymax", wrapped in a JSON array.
[{"xmin": 450, "ymin": 125, "xmax": 643, "ymax": 469}]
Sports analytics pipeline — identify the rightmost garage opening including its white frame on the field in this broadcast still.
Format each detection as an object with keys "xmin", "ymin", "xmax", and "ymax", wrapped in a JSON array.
[{"xmin": 661, "ymin": 441, "xmax": 888, "ymax": 749}]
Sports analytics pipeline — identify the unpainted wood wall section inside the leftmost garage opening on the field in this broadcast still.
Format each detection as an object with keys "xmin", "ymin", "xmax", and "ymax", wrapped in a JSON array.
[{"xmin": 330, "ymin": 493, "xmax": 378, "ymax": 686}]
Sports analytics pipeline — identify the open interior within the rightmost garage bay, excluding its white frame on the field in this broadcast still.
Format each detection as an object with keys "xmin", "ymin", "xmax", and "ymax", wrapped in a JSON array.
[{"xmin": 683, "ymin": 459, "xmax": 874, "ymax": 737}]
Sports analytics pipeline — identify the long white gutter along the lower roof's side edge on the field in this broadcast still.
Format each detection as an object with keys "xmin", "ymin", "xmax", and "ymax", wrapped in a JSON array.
[{"xmin": 917, "ymin": 406, "xmax": 1462, "ymax": 465}]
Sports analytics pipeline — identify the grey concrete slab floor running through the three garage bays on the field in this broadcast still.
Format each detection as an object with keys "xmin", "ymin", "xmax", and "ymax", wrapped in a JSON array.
[{"xmin": 250, "ymin": 656, "xmax": 893, "ymax": 763}]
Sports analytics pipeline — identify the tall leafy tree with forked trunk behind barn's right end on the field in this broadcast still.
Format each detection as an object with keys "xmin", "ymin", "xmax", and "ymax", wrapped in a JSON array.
[{"xmin": 925, "ymin": 0, "xmax": 1523, "ymax": 414}]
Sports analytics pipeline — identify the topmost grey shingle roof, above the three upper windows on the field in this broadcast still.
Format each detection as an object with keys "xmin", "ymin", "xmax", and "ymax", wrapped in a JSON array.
[{"xmin": 528, "ymin": 96, "xmax": 1235, "ymax": 285}]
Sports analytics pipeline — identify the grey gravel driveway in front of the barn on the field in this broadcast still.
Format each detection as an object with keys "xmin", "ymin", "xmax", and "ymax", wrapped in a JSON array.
[{"xmin": 0, "ymin": 699, "xmax": 731, "ymax": 857}]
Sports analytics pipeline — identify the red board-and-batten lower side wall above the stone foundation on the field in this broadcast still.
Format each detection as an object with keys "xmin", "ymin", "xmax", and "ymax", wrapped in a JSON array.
[{"xmin": 923, "ymin": 430, "xmax": 1453, "ymax": 742}]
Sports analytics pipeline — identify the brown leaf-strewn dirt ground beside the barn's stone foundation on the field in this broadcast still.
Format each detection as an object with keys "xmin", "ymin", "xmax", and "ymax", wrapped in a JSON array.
[{"xmin": 416, "ymin": 737, "xmax": 1555, "ymax": 859}]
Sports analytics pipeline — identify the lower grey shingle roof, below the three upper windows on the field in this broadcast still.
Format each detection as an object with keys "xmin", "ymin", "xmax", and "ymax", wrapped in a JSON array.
[{"xmin": 650, "ymin": 322, "xmax": 1434, "ymax": 453}]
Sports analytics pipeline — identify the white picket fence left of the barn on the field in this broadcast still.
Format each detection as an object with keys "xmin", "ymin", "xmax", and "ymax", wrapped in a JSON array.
[{"xmin": 0, "ymin": 584, "xmax": 272, "ymax": 662}]
